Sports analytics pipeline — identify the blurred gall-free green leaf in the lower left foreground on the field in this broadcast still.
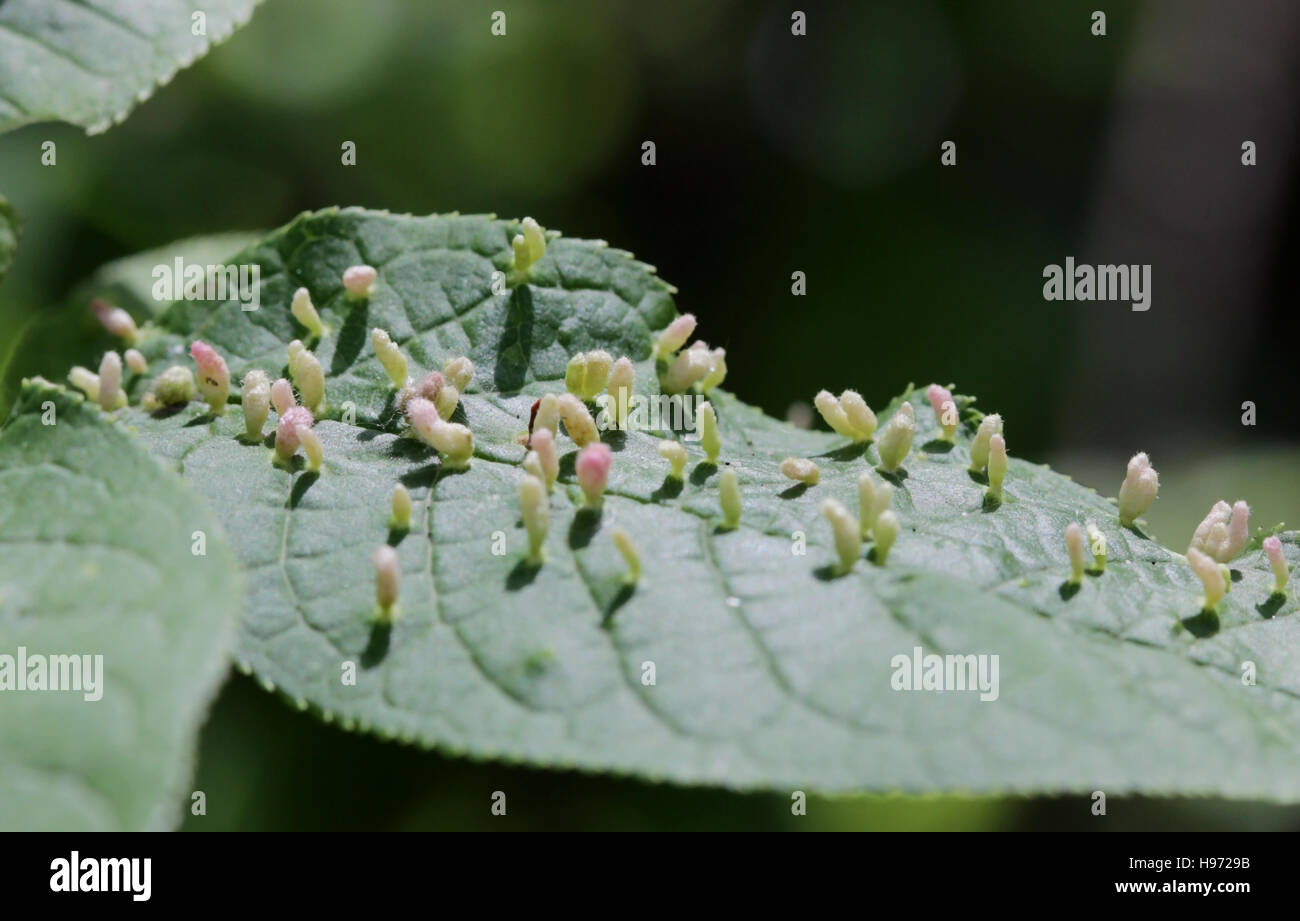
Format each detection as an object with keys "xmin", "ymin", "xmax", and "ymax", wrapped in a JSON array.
[{"xmin": 0, "ymin": 381, "xmax": 241, "ymax": 830}]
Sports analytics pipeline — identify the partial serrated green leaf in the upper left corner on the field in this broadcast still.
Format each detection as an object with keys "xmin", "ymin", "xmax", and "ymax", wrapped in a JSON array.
[{"xmin": 0, "ymin": 0, "xmax": 257, "ymax": 134}]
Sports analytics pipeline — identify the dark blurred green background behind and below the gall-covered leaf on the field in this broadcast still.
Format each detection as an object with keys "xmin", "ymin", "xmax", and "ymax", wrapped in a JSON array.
[{"xmin": 0, "ymin": 0, "xmax": 1300, "ymax": 829}]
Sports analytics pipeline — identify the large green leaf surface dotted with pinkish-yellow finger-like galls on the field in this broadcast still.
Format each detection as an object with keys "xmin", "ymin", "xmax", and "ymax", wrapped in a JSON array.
[{"xmin": 109, "ymin": 209, "xmax": 1300, "ymax": 800}]
